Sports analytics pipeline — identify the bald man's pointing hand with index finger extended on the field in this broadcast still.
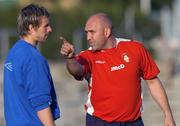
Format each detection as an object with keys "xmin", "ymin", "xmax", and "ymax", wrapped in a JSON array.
[{"xmin": 59, "ymin": 37, "xmax": 75, "ymax": 59}]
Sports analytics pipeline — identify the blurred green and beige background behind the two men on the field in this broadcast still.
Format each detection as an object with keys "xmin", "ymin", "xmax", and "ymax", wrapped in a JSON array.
[{"xmin": 0, "ymin": 0, "xmax": 180, "ymax": 126}]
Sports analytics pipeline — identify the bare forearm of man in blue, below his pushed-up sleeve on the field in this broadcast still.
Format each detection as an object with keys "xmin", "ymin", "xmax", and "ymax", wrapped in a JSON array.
[{"xmin": 37, "ymin": 107, "xmax": 56, "ymax": 126}]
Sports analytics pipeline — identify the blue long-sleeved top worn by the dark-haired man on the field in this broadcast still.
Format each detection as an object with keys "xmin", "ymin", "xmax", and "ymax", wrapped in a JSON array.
[{"xmin": 4, "ymin": 39, "xmax": 60, "ymax": 126}]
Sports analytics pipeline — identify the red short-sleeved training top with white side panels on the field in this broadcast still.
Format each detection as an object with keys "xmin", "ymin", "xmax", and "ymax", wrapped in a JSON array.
[{"xmin": 76, "ymin": 39, "xmax": 160, "ymax": 122}]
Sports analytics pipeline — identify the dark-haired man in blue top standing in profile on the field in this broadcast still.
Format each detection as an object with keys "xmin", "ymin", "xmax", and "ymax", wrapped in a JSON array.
[{"xmin": 4, "ymin": 4, "xmax": 60, "ymax": 126}]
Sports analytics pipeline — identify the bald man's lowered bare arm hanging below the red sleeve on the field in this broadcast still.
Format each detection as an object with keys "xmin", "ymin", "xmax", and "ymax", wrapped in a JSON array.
[{"xmin": 146, "ymin": 77, "xmax": 175, "ymax": 126}]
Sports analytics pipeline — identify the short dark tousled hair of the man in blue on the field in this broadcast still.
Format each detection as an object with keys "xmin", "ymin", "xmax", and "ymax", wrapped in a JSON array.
[{"xmin": 17, "ymin": 4, "xmax": 50, "ymax": 36}]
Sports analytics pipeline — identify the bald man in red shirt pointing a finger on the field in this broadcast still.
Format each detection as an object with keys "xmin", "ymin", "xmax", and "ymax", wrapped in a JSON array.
[{"xmin": 60, "ymin": 13, "xmax": 175, "ymax": 126}]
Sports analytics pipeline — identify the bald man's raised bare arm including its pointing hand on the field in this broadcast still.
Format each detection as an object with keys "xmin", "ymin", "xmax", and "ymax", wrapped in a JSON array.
[{"xmin": 60, "ymin": 38, "xmax": 85, "ymax": 78}]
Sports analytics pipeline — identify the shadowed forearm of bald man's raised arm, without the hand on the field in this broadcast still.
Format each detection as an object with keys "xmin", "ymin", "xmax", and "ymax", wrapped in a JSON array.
[{"xmin": 66, "ymin": 58, "xmax": 85, "ymax": 77}]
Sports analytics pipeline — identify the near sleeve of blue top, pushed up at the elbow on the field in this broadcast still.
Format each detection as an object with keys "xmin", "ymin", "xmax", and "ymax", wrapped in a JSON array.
[{"xmin": 25, "ymin": 54, "xmax": 52, "ymax": 111}]
